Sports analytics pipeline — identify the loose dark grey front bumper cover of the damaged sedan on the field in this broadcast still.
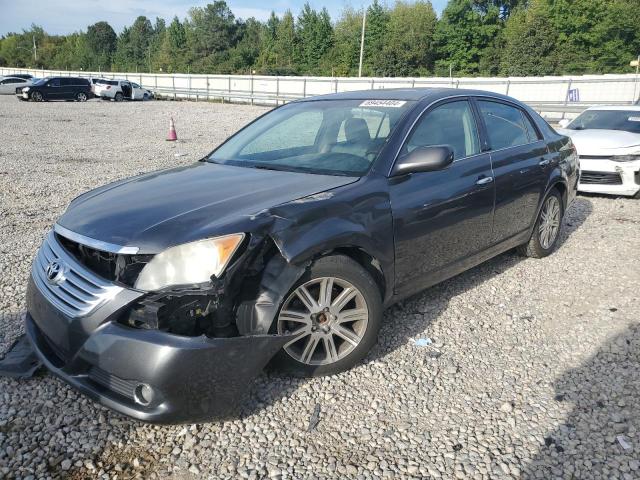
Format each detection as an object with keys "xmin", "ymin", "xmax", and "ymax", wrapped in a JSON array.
[{"xmin": 25, "ymin": 232, "xmax": 290, "ymax": 423}]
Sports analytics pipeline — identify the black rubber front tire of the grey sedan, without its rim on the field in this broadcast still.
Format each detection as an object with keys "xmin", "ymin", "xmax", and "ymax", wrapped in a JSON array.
[{"xmin": 271, "ymin": 255, "xmax": 383, "ymax": 377}]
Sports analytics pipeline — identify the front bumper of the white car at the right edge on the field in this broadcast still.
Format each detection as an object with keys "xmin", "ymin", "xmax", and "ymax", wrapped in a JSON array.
[{"xmin": 578, "ymin": 158, "xmax": 640, "ymax": 196}]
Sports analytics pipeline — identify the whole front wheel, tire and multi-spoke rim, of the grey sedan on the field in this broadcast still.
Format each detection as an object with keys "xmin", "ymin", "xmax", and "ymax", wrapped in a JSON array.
[{"xmin": 274, "ymin": 256, "xmax": 382, "ymax": 376}]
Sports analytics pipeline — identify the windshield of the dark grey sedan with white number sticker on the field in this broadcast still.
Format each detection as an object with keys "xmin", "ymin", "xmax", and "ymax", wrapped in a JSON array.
[{"xmin": 208, "ymin": 100, "xmax": 413, "ymax": 176}]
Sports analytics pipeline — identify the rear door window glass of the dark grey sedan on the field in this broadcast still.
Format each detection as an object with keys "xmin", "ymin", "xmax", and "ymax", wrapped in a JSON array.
[{"xmin": 478, "ymin": 100, "xmax": 530, "ymax": 150}]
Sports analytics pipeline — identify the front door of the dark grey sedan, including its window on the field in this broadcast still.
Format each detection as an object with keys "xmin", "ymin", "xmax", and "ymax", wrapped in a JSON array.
[{"xmin": 389, "ymin": 99, "xmax": 495, "ymax": 295}]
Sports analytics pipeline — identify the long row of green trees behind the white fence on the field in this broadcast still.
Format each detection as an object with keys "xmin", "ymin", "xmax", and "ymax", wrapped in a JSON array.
[{"xmin": 0, "ymin": 0, "xmax": 640, "ymax": 77}]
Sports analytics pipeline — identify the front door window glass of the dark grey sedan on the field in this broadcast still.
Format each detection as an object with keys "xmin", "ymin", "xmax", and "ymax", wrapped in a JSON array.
[{"xmin": 402, "ymin": 100, "xmax": 480, "ymax": 160}]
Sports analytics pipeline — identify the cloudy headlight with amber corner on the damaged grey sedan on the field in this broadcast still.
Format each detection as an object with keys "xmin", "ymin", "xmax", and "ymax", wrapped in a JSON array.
[{"xmin": 135, "ymin": 233, "xmax": 244, "ymax": 290}]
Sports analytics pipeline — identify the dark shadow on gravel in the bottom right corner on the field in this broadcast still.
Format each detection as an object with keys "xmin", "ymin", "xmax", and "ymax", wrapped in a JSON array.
[{"xmin": 521, "ymin": 324, "xmax": 640, "ymax": 479}]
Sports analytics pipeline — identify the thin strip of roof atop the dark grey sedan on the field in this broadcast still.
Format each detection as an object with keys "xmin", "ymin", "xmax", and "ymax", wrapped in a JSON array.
[{"xmin": 298, "ymin": 88, "xmax": 520, "ymax": 103}]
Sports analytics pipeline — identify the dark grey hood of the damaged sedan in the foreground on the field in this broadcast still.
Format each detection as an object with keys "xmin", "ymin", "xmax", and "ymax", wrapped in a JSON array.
[{"xmin": 58, "ymin": 162, "xmax": 357, "ymax": 253}]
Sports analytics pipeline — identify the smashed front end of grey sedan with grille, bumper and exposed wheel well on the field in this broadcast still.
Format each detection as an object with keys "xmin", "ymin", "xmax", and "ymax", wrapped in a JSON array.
[{"xmin": 26, "ymin": 227, "xmax": 305, "ymax": 423}]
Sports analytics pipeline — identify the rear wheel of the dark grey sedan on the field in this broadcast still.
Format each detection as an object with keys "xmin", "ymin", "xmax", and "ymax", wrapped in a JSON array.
[{"xmin": 518, "ymin": 189, "xmax": 564, "ymax": 258}]
